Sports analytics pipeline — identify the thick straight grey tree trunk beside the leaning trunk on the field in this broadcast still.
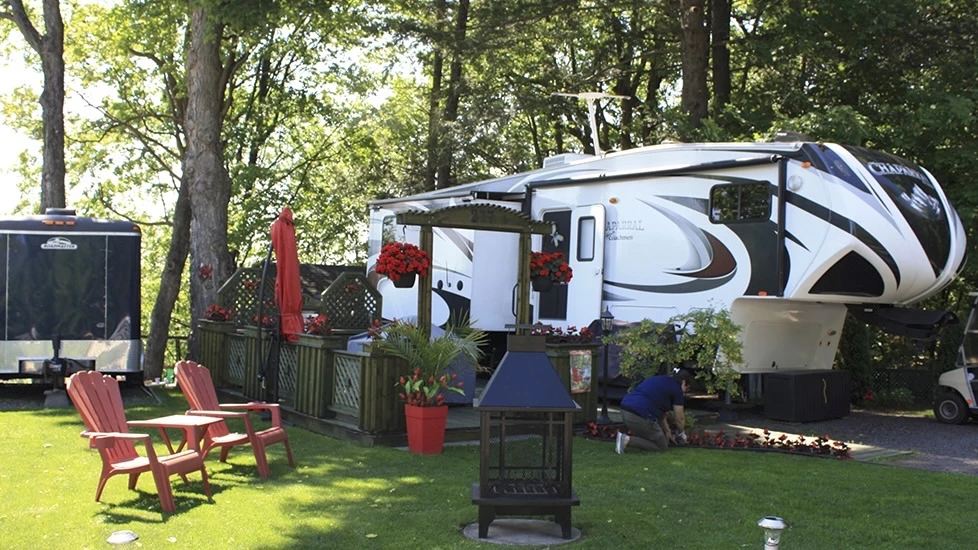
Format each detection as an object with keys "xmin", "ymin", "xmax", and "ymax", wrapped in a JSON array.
[{"xmin": 184, "ymin": 7, "xmax": 231, "ymax": 358}]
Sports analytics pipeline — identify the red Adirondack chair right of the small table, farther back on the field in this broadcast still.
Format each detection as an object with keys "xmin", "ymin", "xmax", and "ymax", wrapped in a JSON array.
[{"xmin": 176, "ymin": 361, "xmax": 295, "ymax": 477}]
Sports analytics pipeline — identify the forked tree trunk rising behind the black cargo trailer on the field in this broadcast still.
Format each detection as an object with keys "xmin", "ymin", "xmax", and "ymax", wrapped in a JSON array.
[{"xmin": 4, "ymin": 0, "xmax": 65, "ymax": 213}]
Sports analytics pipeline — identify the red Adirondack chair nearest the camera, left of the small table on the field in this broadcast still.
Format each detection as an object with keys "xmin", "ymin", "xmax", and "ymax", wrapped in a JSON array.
[{"xmin": 68, "ymin": 371, "xmax": 211, "ymax": 512}]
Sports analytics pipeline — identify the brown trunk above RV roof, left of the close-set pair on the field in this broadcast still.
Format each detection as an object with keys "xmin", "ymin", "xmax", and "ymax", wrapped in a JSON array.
[{"xmin": 680, "ymin": 0, "xmax": 710, "ymax": 133}]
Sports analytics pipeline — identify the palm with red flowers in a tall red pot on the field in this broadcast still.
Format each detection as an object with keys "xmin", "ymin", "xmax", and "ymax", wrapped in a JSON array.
[{"xmin": 373, "ymin": 319, "xmax": 487, "ymax": 454}]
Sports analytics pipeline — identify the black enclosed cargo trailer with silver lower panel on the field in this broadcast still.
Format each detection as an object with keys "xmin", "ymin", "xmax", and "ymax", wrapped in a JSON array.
[{"xmin": 0, "ymin": 209, "xmax": 142, "ymax": 385}]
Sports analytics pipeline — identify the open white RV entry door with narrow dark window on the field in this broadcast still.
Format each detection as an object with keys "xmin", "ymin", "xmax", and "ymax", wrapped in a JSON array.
[{"xmin": 567, "ymin": 204, "xmax": 605, "ymax": 328}]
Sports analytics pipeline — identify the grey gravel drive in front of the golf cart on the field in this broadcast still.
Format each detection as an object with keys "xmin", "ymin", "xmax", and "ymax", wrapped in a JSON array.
[{"xmin": 700, "ymin": 410, "xmax": 978, "ymax": 475}]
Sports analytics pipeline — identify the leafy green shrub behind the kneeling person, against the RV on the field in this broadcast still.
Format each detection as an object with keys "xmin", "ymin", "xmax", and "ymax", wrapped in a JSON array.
[{"xmin": 607, "ymin": 307, "xmax": 744, "ymax": 396}]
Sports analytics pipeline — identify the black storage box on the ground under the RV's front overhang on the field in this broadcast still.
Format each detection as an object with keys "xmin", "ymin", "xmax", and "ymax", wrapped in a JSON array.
[{"xmin": 763, "ymin": 370, "xmax": 850, "ymax": 422}]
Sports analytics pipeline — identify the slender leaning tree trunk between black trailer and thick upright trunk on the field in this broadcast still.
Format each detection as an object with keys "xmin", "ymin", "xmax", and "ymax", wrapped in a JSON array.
[{"xmin": 143, "ymin": 178, "xmax": 191, "ymax": 380}]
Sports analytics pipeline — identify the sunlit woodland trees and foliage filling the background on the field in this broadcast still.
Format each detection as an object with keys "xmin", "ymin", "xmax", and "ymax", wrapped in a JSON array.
[{"xmin": 0, "ymin": 0, "xmax": 978, "ymax": 380}]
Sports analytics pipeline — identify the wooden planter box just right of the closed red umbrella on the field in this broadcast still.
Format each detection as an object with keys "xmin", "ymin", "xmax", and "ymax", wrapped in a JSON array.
[{"xmin": 288, "ymin": 334, "xmax": 346, "ymax": 418}]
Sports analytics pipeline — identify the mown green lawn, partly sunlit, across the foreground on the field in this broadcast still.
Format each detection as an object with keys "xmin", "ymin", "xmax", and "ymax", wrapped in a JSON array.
[{"xmin": 0, "ymin": 392, "xmax": 978, "ymax": 550}]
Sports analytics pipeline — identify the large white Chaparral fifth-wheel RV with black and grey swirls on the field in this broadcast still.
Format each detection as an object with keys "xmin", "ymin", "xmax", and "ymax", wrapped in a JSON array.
[{"xmin": 367, "ymin": 142, "xmax": 965, "ymax": 373}]
